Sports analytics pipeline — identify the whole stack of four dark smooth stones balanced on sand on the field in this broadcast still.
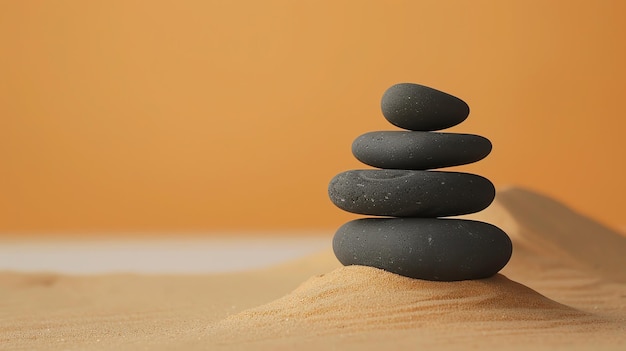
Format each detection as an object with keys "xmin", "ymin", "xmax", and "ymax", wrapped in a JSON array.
[{"xmin": 328, "ymin": 83, "xmax": 512, "ymax": 281}]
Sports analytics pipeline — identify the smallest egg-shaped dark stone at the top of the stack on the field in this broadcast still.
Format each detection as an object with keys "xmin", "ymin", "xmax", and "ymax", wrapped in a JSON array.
[{"xmin": 381, "ymin": 83, "xmax": 469, "ymax": 132}]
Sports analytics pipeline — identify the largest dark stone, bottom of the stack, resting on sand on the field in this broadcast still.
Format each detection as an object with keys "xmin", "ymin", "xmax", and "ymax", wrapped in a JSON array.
[{"xmin": 333, "ymin": 218, "xmax": 513, "ymax": 281}]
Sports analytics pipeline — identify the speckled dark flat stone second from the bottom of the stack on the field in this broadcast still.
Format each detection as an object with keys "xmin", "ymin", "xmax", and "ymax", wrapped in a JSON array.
[{"xmin": 328, "ymin": 169, "xmax": 496, "ymax": 217}]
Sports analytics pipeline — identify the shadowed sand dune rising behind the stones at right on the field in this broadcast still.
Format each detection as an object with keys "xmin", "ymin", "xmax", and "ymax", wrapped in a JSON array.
[{"xmin": 483, "ymin": 188, "xmax": 626, "ymax": 283}]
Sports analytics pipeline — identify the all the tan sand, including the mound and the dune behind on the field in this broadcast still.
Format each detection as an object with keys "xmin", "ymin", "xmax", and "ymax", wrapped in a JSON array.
[{"xmin": 0, "ymin": 188, "xmax": 626, "ymax": 350}]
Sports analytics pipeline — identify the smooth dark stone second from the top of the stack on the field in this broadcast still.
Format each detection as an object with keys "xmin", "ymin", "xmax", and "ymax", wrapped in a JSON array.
[{"xmin": 352, "ymin": 131, "xmax": 491, "ymax": 170}]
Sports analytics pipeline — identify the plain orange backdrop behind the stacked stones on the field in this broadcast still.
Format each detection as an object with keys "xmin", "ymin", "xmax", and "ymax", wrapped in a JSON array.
[{"xmin": 0, "ymin": 0, "xmax": 626, "ymax": 233}]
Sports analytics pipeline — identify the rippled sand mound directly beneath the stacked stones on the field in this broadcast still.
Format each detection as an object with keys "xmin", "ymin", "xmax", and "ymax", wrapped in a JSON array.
[{"xmin": 208, "ymin": 266, "xmax": 593, "ymax": 343}]
